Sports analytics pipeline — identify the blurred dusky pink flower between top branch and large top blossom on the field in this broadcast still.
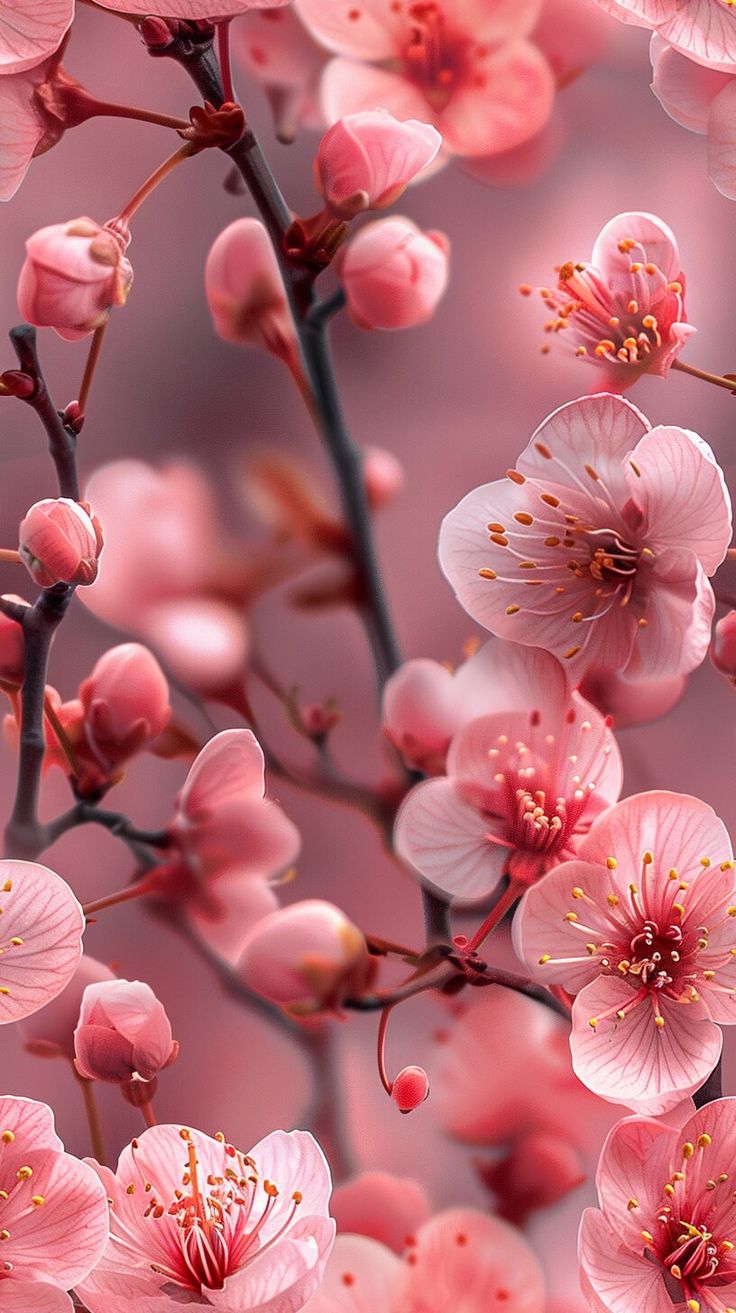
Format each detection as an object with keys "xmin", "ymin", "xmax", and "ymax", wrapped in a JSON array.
[{"xmin": 231, "ymin": 5, "xmax": 329, "ymax": 142}]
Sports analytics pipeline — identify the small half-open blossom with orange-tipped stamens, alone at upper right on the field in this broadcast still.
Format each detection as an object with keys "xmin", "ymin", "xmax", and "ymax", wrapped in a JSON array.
[{"xmin": 521, "ymin": 213, "xmax": 695, "ymax": 391}]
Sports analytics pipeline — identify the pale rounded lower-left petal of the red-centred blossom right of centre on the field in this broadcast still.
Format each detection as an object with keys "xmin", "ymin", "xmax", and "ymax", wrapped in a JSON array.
[{"xmin": 394, "ymin": 780, "xmax": 509, "ymax": 898}]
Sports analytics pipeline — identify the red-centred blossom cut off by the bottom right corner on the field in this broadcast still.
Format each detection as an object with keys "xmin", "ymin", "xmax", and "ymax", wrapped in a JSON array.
[{"xmin": 580, "ymin": 1099, "xmax": 736, "ymax": 1313}]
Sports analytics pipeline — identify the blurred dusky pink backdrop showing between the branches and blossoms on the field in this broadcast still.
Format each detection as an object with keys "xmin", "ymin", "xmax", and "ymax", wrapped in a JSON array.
[{"xmin": 0, "ymin": 7, "xmax": 736, "ymax": 1292}]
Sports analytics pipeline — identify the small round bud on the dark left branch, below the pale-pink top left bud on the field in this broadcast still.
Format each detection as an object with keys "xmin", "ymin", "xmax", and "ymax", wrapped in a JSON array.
[{"xmin": 18, "ymin": 496, "xmax": 102, "ymax": 588}]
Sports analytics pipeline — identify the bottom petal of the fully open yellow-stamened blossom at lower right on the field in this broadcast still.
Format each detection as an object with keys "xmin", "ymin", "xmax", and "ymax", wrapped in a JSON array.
[{"xmin": 571, "ymin": 976, "xmax": 723, "ymax": 1115}]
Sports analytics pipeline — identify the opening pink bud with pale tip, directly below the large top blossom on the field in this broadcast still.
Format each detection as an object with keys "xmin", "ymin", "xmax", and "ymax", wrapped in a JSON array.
[{"xmin": 315, "ymin": 109, "xmax": 442, "ymax": 219}]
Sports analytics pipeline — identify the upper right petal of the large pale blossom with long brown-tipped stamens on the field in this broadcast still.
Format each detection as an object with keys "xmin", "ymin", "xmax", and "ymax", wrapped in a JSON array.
[{"xmin": 628, "ymin": 422, "xmax": 736, "ymax": 575}]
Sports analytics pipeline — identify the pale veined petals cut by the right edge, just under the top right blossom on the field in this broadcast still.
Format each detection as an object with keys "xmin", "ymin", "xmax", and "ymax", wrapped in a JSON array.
[{"xmin": 651, "ymin": 35, "xmax": 736, "ymax": 200}]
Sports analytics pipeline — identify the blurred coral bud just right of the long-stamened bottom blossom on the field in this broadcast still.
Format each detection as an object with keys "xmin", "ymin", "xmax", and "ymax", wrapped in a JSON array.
[{"xmin": 332, "ymin": 1171, "xmax": 430, "ymax": 1254}]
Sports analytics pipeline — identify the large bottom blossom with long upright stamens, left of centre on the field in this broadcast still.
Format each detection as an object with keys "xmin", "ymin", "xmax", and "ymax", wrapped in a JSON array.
[{"xmin": 77, "ymin": 1125, "xmax": 335, "ymax": 1313}]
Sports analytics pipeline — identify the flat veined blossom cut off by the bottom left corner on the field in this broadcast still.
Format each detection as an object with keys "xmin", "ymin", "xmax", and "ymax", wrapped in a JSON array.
[{"xmin": 0, "ymin": 1095, "xmax": 109, "ymax": 1313}]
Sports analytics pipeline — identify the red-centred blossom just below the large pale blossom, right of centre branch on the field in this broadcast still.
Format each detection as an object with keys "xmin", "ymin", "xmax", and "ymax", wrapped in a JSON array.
[{"xmin": 394, "ymin": 650, "xmax": 622, "ymax": 899}]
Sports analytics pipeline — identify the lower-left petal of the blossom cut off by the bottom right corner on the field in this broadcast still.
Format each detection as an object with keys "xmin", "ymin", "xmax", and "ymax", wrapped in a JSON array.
[{"xmin": 579, "ymin": 1208, "xmax": 673, "ymax": 1313}]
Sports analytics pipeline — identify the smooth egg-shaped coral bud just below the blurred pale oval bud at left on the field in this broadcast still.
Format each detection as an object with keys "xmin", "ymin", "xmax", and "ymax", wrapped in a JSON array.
[{"xmin": 79, "ymin": 643, "xmax": 171, "ymax": 764}]
